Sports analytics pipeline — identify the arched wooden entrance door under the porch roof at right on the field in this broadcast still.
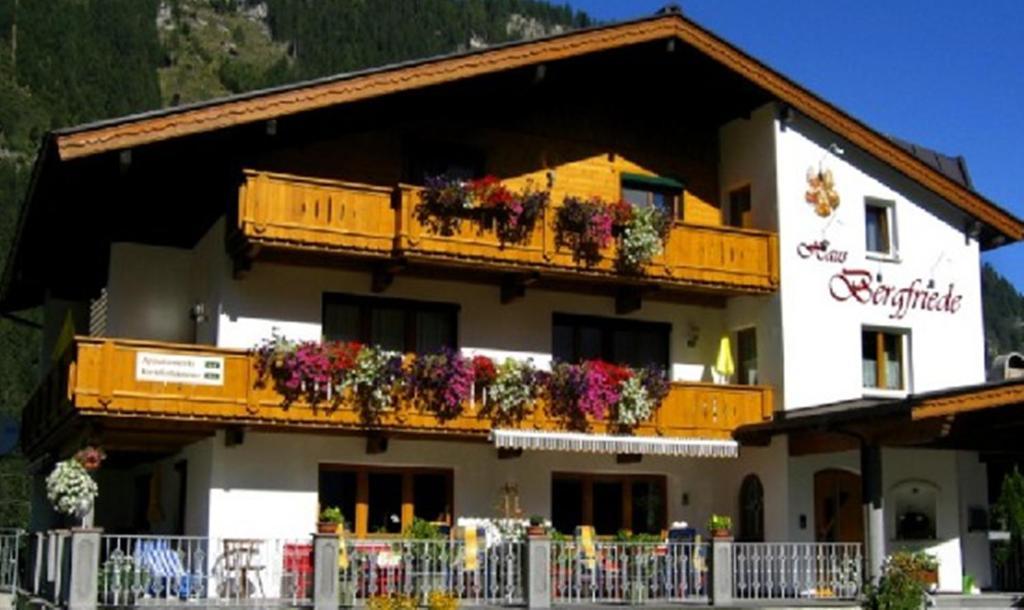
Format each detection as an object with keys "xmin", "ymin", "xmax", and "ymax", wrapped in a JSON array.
[{"xmin": 814, "ymin": 469, "xmax": 864, "ymax": 542}]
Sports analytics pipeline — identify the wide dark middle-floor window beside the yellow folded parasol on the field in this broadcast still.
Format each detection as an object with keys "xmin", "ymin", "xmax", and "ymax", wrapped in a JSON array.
[{"xmin": 552, "ymin": 313, "xmax": 672, "ymax": 371}]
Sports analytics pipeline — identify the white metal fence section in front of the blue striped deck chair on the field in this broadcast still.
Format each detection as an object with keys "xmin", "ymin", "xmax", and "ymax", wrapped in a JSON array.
[{"xmin": 97, "ymin": 535, "xmax": 312, "ymax": 606}]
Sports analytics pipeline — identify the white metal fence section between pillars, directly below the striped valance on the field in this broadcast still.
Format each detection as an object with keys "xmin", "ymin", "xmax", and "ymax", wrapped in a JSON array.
[{"xmin": 551, "ymin": 541, "xmax": 711, "ymax": 604}]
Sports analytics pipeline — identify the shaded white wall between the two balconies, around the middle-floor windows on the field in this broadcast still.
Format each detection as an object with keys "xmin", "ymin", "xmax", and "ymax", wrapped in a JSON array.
[{"xmin": 211, "ymin": 263, "xmax": 724, "ymax": 381}]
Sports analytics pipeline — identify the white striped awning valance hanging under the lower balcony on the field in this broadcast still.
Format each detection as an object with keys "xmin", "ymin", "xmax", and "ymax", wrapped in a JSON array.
[{"xmin": 490, "ymin": 430, "xmax": 739, "ymax": 458}]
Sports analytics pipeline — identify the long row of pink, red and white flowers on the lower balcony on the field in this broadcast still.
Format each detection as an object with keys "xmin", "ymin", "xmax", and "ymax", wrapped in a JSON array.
[{"xmin": 254, "ymin": 334, "xmax": 669, "ymax": 432}]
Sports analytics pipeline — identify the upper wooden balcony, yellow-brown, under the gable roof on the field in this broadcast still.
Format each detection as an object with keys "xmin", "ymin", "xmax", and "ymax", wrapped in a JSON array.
[{"xmin": 239, "ymin": 171, "xmax": 778, "ymax": 294}]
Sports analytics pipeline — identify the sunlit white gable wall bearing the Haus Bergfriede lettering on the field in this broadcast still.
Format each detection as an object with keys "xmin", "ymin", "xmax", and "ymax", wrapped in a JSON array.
[{"xmin": 775, "ymin": 112, "xmax": 985, "ymax": 408}]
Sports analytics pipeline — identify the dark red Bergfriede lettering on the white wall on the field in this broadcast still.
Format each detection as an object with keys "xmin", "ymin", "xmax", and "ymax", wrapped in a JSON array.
[{"xmin": 828, "ymin": 269, "xmax": 964, "ymax": 319}]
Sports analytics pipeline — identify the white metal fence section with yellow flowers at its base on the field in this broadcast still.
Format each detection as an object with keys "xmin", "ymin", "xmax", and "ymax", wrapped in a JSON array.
[{"xmin": 339, "ymin": 538, "xmax": 525, "ymax": 606}]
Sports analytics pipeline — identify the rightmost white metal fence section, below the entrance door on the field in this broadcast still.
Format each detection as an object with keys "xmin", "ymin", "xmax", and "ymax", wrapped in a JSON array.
[{"xmin": 732, "ymin": 542, "xmax": 863, "ymax": 601}]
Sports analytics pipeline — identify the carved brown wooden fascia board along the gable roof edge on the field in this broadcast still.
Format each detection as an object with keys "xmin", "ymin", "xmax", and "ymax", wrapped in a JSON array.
[{"xmin": 36, "ymin": 9, "xmax": 1024, "ymax": 241}]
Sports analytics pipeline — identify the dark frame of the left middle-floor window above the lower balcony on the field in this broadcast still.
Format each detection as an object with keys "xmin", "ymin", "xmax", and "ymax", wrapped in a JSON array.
[{"xmin": 321, "ymin": 293, "xmax": 462, "ymax": 353}]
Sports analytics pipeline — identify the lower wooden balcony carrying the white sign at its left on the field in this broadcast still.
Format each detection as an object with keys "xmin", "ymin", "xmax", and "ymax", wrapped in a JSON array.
[{"xmin": 23, "ymin": 337, "xmax": 773, "ymax": 452}]
